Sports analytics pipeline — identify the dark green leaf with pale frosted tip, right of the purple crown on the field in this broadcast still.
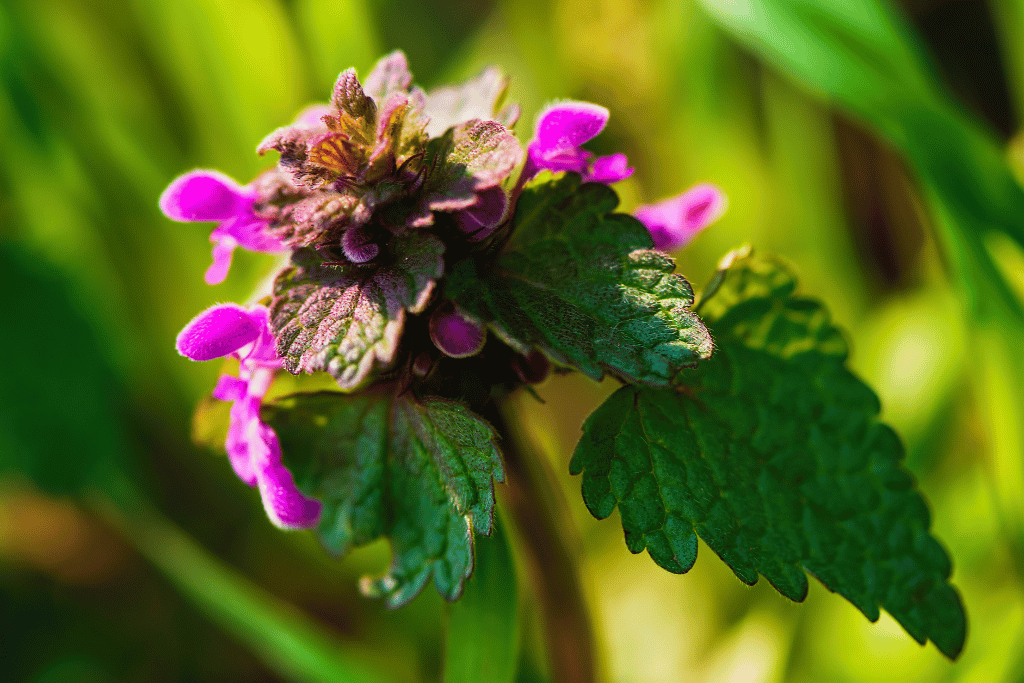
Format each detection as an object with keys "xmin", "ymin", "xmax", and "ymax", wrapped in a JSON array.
[{"xmin": 445, "ymin": 174, "xmax": 712, "ymax": 386}]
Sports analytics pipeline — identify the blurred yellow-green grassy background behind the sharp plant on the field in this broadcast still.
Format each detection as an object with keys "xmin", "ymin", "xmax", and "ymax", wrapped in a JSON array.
[{"xmin": 0, "ymin": 0, "xmax": 1024, "ymax": 683}]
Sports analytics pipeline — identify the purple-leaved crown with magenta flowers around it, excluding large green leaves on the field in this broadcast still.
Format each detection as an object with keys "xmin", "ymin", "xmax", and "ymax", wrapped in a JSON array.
[{"xmin": 160, "ymin": 52, "xmax": 724, "ymax": 528}]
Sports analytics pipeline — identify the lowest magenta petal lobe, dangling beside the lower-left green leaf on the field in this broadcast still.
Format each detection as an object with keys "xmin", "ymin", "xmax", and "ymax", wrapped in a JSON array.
[{"xmin": 249, "ymin": 421, "xmax": 322, "ymax": 529}]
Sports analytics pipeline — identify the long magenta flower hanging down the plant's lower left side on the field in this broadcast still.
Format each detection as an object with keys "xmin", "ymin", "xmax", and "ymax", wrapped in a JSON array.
[{"xmin": 176, "ymin": 303, "xmax": 322, "ymax": 529}]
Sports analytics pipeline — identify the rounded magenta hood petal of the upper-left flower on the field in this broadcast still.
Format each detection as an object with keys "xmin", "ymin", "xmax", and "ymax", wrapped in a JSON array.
[{"xmin": 160, "ymin": 169, "xmax": 252, "ymax": 222}]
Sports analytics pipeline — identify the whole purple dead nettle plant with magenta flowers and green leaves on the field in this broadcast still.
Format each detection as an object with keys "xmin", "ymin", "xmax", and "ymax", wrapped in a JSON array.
[{"xmin": 160, "ymin": 52, "xmax": 966, "ymax": 659}]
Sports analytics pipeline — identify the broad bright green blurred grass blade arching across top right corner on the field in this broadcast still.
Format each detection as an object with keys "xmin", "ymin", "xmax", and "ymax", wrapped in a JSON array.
[{"xmin": 701, "ymin": 0, "xmax": 1024, "ymax": 319}]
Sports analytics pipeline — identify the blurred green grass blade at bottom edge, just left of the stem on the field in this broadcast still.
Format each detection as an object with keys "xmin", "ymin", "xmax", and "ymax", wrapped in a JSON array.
[{"xmin": 443, "ymin": 517, "xmax": 519, "ymax": 683}]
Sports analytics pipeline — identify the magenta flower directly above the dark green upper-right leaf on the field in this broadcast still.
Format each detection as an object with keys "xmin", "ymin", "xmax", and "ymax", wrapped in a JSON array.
[{"xmin": 525, "ymin": 101, "xmax": 633, "ymax": 184}]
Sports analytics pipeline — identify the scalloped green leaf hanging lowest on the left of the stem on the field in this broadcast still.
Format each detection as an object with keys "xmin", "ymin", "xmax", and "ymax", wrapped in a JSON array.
[{"xmin": 263, "ymin": 392, "xmax": 505, "ymax": 606}]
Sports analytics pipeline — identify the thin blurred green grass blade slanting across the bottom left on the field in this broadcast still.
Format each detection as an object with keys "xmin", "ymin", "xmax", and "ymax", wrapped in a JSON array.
[{"xmin": 97, "ymin": 481, "xmax": 393, "ymax": 683}]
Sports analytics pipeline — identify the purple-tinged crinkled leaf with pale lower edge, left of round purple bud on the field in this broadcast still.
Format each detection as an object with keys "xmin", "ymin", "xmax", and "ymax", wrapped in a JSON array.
[{"xmin": 270, "ymin": 231, "xmax": 444, "ymax": 389}]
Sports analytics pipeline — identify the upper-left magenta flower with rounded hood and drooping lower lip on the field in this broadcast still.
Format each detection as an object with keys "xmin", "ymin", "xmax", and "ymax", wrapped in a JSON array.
[{"xmin": 160, "ymin": 169, "xmax": 285, "ymax": 285}]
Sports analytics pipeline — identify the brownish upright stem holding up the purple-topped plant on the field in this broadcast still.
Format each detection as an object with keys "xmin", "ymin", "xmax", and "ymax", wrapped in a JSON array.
[{"xmin": 487, "ymin": 407, "xmax": 596, "ymax": 683}]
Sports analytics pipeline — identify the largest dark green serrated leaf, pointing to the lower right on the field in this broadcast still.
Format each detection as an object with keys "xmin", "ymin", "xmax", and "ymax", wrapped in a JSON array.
[{"xmin": 570, "ymin": 255, "xmax": 966, "ymax": 657}]
